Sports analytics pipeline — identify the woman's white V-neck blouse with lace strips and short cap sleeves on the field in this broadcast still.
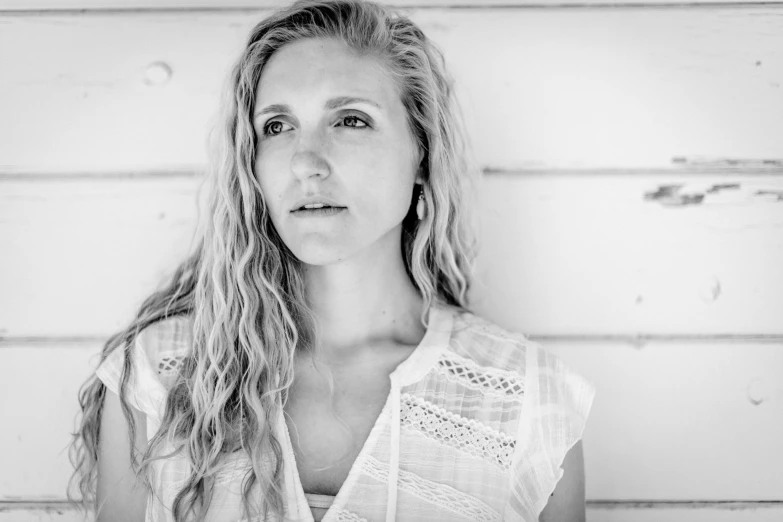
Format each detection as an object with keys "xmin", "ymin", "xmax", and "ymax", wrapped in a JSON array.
[{"xmin": 95, "ymin": 304, "xmax": 595, "ymax": 522}]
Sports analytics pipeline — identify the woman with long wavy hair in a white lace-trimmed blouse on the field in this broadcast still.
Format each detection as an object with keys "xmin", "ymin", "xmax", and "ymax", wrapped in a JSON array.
[{"xmin": 69, "ymin": 0, "xmax": 594, "ymax": 521}]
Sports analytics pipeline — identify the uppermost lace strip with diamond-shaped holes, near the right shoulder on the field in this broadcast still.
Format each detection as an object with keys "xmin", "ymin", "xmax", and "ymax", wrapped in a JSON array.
[{"xmin": 435, "ymin": 353, "xmax": 525, "ymax": 400}]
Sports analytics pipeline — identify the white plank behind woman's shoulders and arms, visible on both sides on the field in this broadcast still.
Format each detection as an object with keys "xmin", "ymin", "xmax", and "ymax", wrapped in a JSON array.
[{"xmin": 0, "ymin": 340, "xmax": 783, "ymax": 498}]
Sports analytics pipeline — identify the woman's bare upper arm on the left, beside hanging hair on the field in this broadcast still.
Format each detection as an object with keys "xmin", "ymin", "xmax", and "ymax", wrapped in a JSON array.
[{"xmin": 96, "ymin": 389, "xmax": 147, "ymax": 522}]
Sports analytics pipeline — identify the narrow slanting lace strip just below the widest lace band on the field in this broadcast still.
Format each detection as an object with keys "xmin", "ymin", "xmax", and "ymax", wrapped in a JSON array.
[{"xmin": 362, "ymin": 456, "xmax": 501, "ymax": 521}]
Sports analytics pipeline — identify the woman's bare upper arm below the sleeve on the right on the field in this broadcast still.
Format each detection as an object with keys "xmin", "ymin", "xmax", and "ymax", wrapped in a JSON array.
[{"xmin": 538, "ymin": 440, "xmax": 585, "ymax": 522}]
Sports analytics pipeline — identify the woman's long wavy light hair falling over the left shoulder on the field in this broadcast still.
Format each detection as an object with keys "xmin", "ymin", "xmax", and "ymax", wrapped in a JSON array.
[{"xmin": 67, "ymin": 0, "xmax": 480, "ymax": 522}]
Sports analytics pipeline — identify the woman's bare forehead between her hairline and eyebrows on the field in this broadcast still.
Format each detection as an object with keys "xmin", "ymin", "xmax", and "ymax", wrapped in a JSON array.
[{"xmin": 256, "ymin": 38, "xmax": 396, "ymax": 107}]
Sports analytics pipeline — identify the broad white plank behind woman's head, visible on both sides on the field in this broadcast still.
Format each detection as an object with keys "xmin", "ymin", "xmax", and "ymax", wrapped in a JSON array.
[{"xmin": 0, "ymin": 5, "xmax": 783, "ymax": 172}]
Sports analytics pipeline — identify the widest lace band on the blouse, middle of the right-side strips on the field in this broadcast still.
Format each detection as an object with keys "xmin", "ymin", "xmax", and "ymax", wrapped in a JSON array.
[{"xmin": 400, "ymin": 393, "xmax": 516, "ymax": 470}]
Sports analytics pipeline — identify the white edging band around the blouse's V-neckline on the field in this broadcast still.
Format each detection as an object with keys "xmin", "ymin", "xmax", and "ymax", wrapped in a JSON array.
[{"xmin": 277, "ymin": 303, "xmax": 451, "ymax": 522}]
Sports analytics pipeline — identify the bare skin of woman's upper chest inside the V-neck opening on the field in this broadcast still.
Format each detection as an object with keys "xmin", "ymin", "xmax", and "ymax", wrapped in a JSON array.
[{"xmin": 285, "ymin": 347, "xmax": 414, "ymax": 495}]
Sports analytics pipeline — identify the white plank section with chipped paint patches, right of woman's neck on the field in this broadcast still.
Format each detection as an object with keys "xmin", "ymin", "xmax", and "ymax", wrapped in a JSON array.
[{"xmin": 473, "ymin": 172, "xmax": 783, "ymax": 336}]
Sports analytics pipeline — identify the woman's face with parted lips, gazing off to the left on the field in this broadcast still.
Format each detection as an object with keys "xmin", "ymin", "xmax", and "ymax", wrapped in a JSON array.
[{"xmin": 253, "ymin": 38, "xmax": 423, "ymax": 265}]
